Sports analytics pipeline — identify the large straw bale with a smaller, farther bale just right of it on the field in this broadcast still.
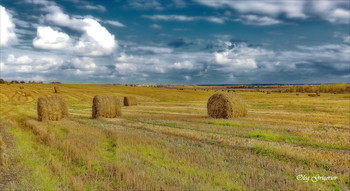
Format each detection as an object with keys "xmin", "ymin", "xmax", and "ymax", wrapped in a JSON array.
[{"xmin": 92, "ymin": 95, "xmax": 122, "ymax": 119}]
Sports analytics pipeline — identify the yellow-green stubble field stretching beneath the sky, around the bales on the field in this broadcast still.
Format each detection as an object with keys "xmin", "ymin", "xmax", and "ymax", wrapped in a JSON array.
[{"xmin": 0, "ymin": 84, "xmax": 350, "ymax": 190}]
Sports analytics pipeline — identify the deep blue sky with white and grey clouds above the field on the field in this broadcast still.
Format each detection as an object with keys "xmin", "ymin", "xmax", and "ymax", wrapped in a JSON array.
[{"xmin": 0, "ymin": 0, "xmax": 350, "ymax": 84}]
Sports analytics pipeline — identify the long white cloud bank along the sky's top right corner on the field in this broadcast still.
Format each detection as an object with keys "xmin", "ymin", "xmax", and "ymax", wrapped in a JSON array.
[{"xmin": 195, "ymin": 0, "xmax": 350, "ymax": 24}]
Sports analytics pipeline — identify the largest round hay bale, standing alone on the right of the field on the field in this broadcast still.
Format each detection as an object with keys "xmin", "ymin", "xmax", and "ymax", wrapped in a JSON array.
[{"xmin": 207, "ymin": 93, "xmax": 247, "ymax": 119}]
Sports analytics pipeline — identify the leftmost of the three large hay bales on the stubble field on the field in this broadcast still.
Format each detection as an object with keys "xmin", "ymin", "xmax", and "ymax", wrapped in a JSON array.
[{"xmin": 38, "ymin": 96, "xmax": 68, "ymax": 121}]
